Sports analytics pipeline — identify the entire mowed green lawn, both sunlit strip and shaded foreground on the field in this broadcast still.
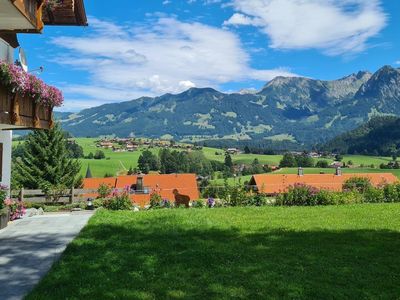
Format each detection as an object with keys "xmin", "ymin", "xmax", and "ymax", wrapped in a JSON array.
[{"xmin": 27, "ymin": 204, "xmax": 400, "ymax": 299}]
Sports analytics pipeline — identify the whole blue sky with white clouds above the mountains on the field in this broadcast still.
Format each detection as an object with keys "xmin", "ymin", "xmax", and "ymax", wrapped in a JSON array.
[{"xmin": 19, "ymin": 0, "xmax": 400, "ymax": 111}]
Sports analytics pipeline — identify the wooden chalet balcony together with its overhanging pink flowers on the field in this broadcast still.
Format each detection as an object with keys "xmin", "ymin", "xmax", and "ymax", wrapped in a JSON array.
[{"xmin": 0, "ymin": 61, "xmax": 63, "ymax": 129}]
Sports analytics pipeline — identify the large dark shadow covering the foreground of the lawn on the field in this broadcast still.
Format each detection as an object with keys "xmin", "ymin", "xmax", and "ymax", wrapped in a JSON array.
[{"xmin": 28, "ymin": 216, "xmax": 400, "ymax": 299}]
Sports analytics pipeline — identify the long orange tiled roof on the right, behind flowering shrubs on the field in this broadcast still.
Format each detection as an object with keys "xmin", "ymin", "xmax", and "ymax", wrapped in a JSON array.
[{"xmin": 250, "ymin": 173, "xmax": 398, "ymax": 194}]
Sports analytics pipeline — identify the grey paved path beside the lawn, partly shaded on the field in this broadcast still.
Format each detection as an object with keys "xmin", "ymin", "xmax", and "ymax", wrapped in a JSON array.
[{"xmin": 0, "ymin": 212, "xmax": 93, "ymax": 300}]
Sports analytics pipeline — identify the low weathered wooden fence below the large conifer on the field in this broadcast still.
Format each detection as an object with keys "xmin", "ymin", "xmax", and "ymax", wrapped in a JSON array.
[{"xmin": 11, "ymin": 188, "xmax": 109, "ymax": 203}]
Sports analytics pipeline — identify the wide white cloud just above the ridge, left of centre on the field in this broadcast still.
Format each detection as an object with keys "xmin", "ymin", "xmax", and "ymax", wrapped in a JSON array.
[{"xmin": 52, "ymin": 17, "xmax": 293, "ymax": 105}]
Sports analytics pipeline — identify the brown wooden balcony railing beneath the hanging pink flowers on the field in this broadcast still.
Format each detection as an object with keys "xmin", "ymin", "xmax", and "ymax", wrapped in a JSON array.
[{"xmin": 0, "ymin": 86, "xmax": 54, "ymax": 130}]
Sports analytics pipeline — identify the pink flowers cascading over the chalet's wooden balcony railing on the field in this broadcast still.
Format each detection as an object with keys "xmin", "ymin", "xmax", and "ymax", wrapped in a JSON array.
[{"xmin": 0, "ymin": 60, "xmax": 64, "ymax": 106}]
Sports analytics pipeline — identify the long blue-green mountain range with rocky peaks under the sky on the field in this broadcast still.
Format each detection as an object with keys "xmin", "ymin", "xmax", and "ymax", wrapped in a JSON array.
[{"xmin": 56, "ymin": 66, "xmax": 400, "ymax": 148}]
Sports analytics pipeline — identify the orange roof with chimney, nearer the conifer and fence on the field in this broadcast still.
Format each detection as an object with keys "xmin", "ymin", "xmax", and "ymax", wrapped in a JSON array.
[{"xmin": 83, "ymin": 174, "xmax": 200, "ymax": 207}]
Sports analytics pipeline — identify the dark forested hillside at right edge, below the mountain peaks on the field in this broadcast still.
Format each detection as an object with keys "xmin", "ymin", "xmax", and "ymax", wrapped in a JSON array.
[{"xmin": 319, "ymin": 116, "xmax": 400, "ymax": 156}]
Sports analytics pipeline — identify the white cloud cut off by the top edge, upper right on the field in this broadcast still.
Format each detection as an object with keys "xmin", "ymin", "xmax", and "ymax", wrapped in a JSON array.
[{"xmin": 225, "ymin": 0, "xmax": 387, "ymax": 55}]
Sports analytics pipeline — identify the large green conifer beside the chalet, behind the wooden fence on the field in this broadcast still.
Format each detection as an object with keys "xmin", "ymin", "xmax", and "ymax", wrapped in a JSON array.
[{"xmin": 14, "ymin": 124, "xmax": 81, "ymax": 189}]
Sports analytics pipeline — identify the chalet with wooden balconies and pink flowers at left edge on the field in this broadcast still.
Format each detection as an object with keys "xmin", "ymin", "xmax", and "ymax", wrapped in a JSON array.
[{"xmin": 0, "ymin": 0, "xmax": 87, "ymax": 187}]
